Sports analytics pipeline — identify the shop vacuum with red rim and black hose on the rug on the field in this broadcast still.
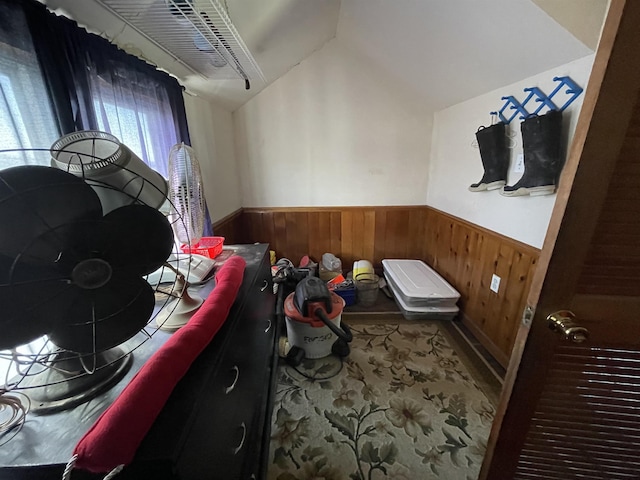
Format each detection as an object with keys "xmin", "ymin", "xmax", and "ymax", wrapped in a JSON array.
[{"xmin": 280, "ymin": 276, "xmax": 353, "ymax": 366}]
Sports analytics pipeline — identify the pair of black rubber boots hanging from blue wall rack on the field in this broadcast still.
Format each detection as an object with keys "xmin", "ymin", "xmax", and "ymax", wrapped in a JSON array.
[{"xmin": 469, "ymin": 110, "xmax": 564, "ymax": 197}]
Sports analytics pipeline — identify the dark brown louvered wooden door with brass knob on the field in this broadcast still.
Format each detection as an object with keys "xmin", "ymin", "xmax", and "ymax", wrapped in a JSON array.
[{"xmin": 480, "ymin": 0, "xmax": 640, "ymax": 480}]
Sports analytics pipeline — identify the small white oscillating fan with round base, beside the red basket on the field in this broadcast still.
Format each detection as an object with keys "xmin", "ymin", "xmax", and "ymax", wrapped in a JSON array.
[{"xmin": 156, "ymin": 143, "xmax": 205, "ymax": 330}]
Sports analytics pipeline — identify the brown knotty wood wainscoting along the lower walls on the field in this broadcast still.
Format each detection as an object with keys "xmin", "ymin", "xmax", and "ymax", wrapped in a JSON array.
[{"xmin": 214, "ymin": 206, "xmax": 540, "ymax": 367}]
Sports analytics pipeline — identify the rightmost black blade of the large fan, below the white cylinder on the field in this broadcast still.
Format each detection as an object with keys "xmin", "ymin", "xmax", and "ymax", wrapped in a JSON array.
[{"xmin": 102, "ymin": 205, "xmax": 173, "ymax": 276}]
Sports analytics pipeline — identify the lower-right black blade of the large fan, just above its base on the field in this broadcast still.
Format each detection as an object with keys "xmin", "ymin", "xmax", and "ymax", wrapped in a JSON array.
[{"xmin": 49, "ymin": 274, "xmax": 155, "ymax": 353}]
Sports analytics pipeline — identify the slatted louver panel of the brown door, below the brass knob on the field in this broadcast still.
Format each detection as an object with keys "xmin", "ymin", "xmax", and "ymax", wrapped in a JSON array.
[{"xmin": 513, "ymin": 342, "xmax": 640, "ymax": 480}]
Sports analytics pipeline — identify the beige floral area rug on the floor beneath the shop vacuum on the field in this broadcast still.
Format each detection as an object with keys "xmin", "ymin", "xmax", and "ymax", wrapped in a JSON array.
[{"xmin": 267, "ymin": 322, "xmax": 494, "ymax": 480}]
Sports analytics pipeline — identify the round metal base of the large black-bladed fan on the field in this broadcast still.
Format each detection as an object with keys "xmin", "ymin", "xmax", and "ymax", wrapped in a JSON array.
[{"xmin": 20, "ymin": 347, "xmax": 133, "ymax": 415}]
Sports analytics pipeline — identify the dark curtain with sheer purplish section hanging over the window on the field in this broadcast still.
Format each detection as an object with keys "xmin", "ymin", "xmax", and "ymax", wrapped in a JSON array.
[{"xmin": 9, "ymin": 0, "xmax": 212, "ymax": 235}]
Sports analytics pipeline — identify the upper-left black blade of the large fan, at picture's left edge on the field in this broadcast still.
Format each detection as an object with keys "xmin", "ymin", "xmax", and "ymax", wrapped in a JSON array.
[{"xmin": 0, "ymin": 165, "xmax": 102, "ymax": 257}]
